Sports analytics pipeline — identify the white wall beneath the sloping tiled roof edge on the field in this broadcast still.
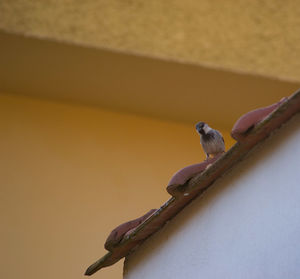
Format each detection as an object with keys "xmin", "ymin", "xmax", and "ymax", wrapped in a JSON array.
[{"xmin": 125, "ymin": 115, "xmax": 300, "ymax": 279}]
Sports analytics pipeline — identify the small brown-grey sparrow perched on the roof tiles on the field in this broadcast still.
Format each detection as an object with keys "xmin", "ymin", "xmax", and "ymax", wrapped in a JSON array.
[{"xmin": 196, "ymin": 122, "xmax": 225, "ymax": 160}]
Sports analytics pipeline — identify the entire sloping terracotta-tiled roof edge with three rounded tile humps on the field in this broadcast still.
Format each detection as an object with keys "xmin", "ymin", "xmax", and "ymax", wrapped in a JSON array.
[{"xmin": 85, "ymin": 90, "xmax": 300, "ymax": 275}]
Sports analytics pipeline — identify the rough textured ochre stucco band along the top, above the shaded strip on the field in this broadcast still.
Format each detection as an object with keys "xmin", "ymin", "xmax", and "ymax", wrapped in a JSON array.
[{"xmin": 0, "ymin": 0, "xmax": 300, "ymax": 81}]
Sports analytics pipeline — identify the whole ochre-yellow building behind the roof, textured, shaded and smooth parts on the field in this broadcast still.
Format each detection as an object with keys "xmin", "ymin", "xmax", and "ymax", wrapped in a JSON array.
[{"xmin": 0, "ymin": 0, "xmax": 300, "ymax": 279}]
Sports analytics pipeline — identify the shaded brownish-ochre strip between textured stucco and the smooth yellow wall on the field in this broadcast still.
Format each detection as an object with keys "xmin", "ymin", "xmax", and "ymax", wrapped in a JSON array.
[{"xmin": 0, "ymin": 30, "xmax": 300, "ymax": 129}]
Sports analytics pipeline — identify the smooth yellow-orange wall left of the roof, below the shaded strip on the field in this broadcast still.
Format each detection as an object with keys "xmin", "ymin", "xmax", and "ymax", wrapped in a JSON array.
[{"xmin": 0, "ymin": 94, "xmax": 233, "ymax": 279}]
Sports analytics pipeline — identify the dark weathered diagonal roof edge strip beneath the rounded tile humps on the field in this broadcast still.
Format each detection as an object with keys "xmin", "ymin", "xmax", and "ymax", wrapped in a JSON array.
[{"xmin": 85, "ymin": 90, "xmax": 300, "ymax": 275}]
